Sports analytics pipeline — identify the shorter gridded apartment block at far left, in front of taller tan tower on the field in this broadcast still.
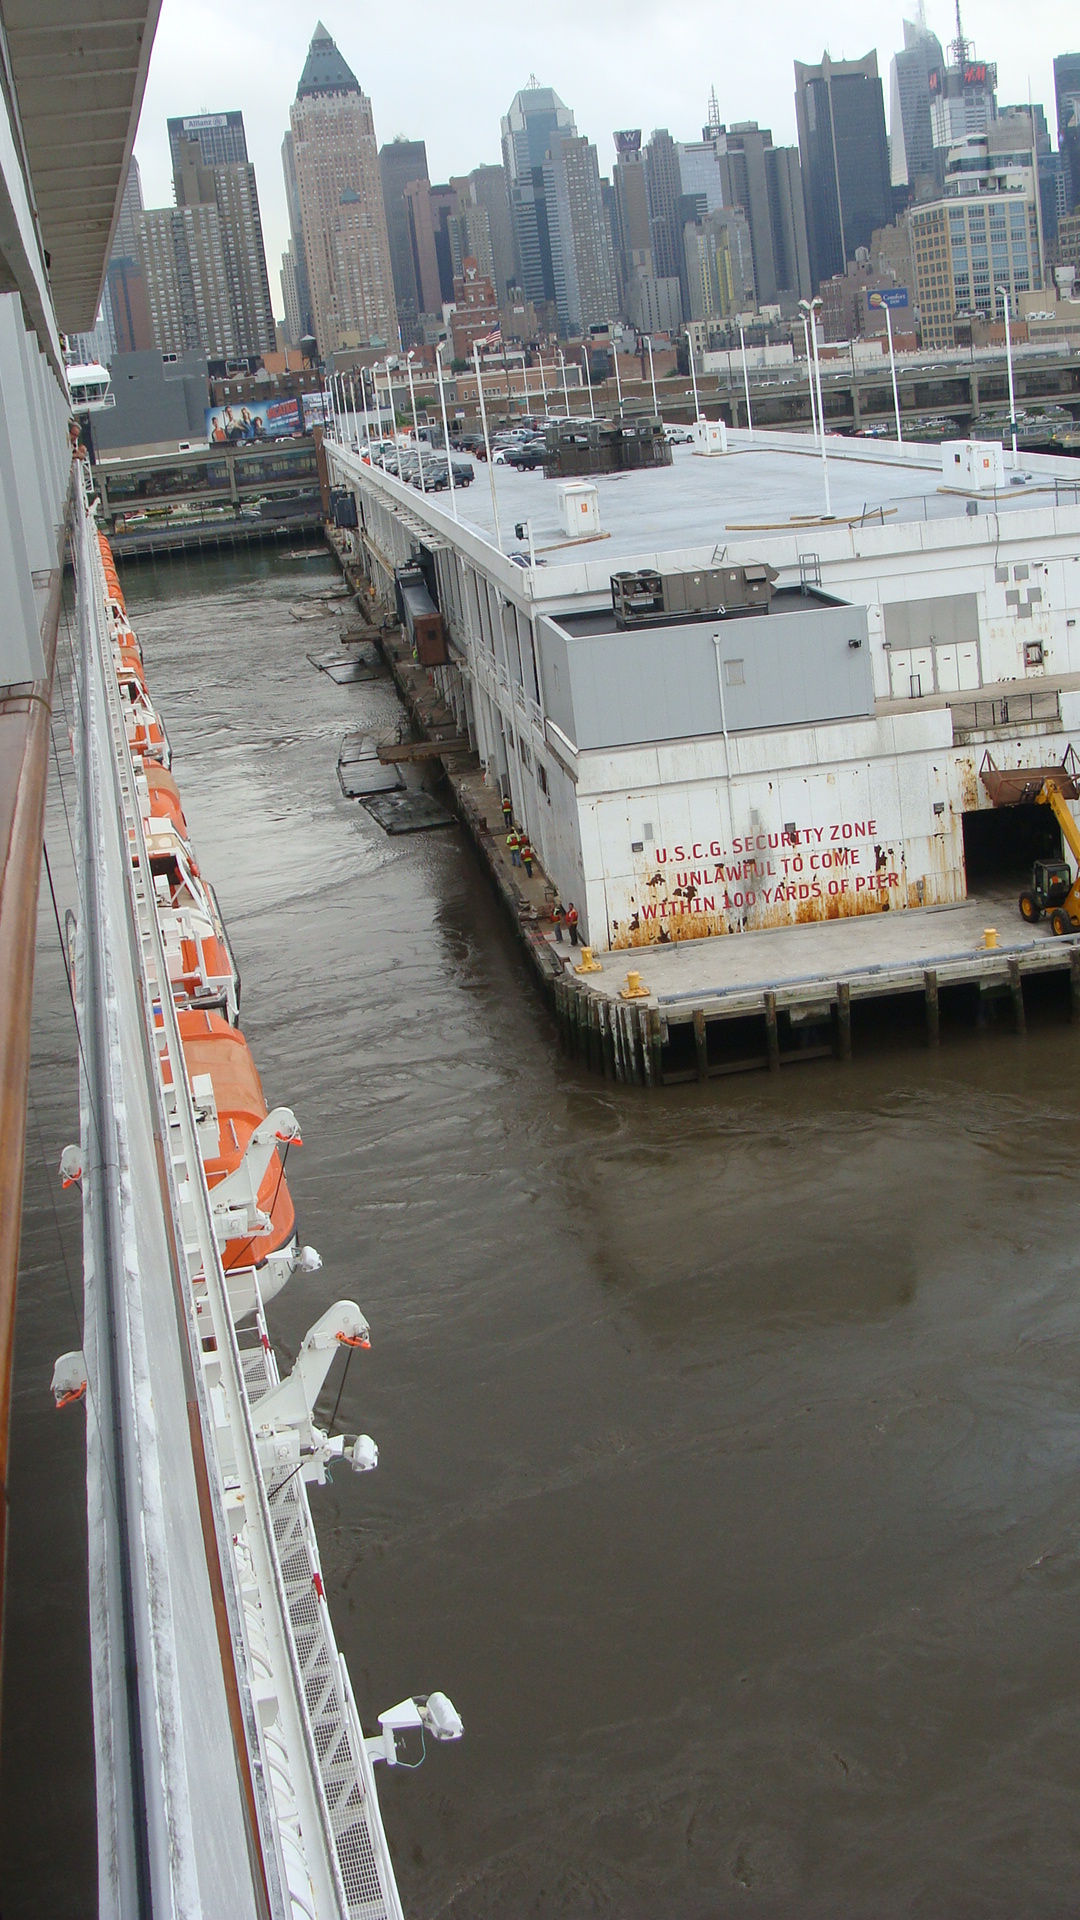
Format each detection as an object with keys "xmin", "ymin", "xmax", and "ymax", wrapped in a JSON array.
[{"xmin": 138, "ymin": 202, "xmax": 240, "ymax": 359}]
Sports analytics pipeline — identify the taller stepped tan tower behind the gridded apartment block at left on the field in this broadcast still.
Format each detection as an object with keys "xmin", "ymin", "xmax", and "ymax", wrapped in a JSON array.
[{"xmin": 169, "ymin": 126, "xmax": 277, "ymax": 359}]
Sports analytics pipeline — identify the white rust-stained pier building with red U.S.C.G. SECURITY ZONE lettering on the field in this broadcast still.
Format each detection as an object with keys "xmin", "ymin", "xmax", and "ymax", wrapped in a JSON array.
[{"xmin": 329, "ymin": 432, "xmax": 1080, "ymax": 950}]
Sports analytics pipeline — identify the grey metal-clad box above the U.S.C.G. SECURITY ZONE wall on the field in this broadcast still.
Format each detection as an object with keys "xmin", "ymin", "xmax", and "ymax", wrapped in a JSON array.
[{"xmin": 540, "ymin": 607, "xmax": 874, "ymax": 749}]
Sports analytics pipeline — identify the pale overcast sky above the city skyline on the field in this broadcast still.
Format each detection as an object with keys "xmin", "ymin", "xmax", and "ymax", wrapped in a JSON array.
[{"xmin": 136, "ymin": 0, "xmax": 1080, "ymax": 313}]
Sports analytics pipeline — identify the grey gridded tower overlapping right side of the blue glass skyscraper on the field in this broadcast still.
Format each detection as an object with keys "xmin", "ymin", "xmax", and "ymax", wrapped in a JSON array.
[{"xmin": 544, "ymin": 134, "xmax": 619, "ymax": 334}]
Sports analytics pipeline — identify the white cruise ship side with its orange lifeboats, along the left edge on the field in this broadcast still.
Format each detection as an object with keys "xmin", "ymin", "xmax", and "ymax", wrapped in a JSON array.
[{"xmin": 0, "ymin": 0, "xmax": 461, "ymax": 1920}]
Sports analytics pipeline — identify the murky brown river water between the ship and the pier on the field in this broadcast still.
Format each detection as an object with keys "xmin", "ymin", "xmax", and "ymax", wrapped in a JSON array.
[{"xmin": 0, "ymin": 555, "xmax": 1080, "ymax": 1920}]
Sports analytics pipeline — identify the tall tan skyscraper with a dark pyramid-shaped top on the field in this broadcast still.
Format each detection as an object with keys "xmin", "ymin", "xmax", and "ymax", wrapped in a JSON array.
[{"xmin": 288, "ymin": 21, "xmax": 398, "ymax": 357}]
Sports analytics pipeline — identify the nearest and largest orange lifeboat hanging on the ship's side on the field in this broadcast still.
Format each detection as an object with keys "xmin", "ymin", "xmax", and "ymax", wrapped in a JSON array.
[{"xmin": 179, "ymin": 1010, "xmax": 296, "ymax": 1300}]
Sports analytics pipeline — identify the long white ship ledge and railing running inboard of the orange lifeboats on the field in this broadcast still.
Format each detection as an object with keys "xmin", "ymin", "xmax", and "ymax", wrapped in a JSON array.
[{"xmin": 75, "ymin": 468, "xmax": 402, "ymax": 1920}]
